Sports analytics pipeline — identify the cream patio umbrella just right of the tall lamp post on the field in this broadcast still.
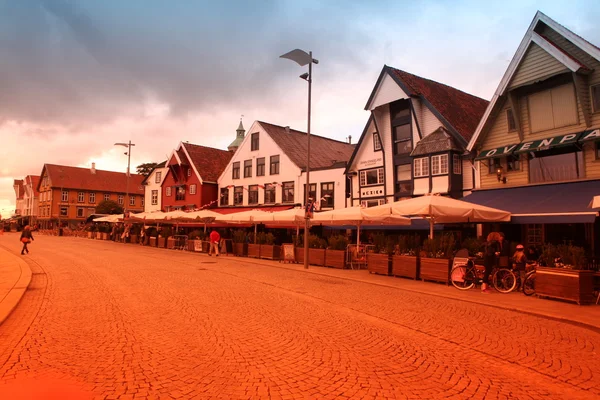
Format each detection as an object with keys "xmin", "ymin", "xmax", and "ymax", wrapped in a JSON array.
[{"xmin": 311, "ymin": 206, "xmax": 410, "ymax": 245}]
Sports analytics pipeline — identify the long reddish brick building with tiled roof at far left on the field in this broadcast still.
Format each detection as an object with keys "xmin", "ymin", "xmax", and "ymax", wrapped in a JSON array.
[{"xmin": 37, "ymin": 163, "xmax": 144, "ymax": 228}]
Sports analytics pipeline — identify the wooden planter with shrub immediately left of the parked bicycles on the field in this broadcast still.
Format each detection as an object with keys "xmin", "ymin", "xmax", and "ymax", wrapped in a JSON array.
[{"xmin": 419, "ymin": 233, "xmax": 455, "ymax": 284}]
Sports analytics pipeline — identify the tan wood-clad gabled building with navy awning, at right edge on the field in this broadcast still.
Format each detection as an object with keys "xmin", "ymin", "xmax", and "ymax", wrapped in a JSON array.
[{"xmin": 466, "ymin": 12, "xmax": 600, "ymax": 252}]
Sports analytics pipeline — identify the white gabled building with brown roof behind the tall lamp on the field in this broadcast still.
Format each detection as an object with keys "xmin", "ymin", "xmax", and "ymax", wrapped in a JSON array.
[{"xmin": 219, "ymin": 121, "xmax": 354, "ymax": 210}]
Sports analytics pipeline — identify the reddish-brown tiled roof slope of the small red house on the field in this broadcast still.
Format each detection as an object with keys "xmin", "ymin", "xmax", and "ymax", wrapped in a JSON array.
[{"xmin": 180, "ymin": 143, "xmax": 233, "ymax": 183}]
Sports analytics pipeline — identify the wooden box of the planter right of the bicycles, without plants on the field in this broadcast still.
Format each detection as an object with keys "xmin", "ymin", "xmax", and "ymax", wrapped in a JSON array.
[{"xmin": 535, "ymin": 267, "xmax": 596, "ymax": 304}]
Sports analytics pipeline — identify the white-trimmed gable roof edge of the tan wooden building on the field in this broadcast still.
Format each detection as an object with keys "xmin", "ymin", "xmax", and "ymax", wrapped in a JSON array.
[{"xmin": 467, "ymin": 11, "xmax": 600, "ymax": 151}]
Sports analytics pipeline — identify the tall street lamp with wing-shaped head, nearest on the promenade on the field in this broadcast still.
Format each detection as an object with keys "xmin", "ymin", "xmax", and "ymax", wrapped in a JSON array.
[{"xmin": 279, "ymin": 49, "xmax": 319, "ymax": 269}]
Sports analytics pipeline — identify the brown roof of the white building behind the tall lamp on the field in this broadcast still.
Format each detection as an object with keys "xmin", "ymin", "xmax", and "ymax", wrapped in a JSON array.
[{"xmin": 257, "ymin": 121, "xmax": 355, "ymax": 169}]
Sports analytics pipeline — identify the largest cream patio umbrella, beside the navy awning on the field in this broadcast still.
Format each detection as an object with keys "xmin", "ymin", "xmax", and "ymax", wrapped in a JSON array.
[{"xmin": 365, "ymin": 195, "xmax": 510, "ymax": 239}]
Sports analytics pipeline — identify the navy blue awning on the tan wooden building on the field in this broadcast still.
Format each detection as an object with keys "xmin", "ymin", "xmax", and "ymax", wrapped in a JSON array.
[{"xmin": 463, "ymin": 180, "xmax": 600, "ymax": 224}]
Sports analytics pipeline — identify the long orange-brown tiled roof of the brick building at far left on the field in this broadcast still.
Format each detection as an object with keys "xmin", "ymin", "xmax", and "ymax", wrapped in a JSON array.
[{"xmin": 37, "ymin": 164, "xmax": 144, "ymax": 194}]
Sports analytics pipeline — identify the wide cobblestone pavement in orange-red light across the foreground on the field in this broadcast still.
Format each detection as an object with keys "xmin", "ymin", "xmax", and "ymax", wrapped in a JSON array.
[{"xmin": 0, "ymin": 236, "xmax": 600, "ymax": 399}]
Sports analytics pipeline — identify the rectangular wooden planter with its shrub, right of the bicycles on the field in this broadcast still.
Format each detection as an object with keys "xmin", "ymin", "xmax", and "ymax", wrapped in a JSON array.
[{"xmin": 535, "ymin": 244, "xmax": 595, "ymax": 304}]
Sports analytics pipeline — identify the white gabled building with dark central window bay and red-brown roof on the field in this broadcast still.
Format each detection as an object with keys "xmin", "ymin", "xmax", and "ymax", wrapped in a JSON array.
[{"xmin": 346, "ymin": 66, "xmax": 488, "ymax": 207}]
